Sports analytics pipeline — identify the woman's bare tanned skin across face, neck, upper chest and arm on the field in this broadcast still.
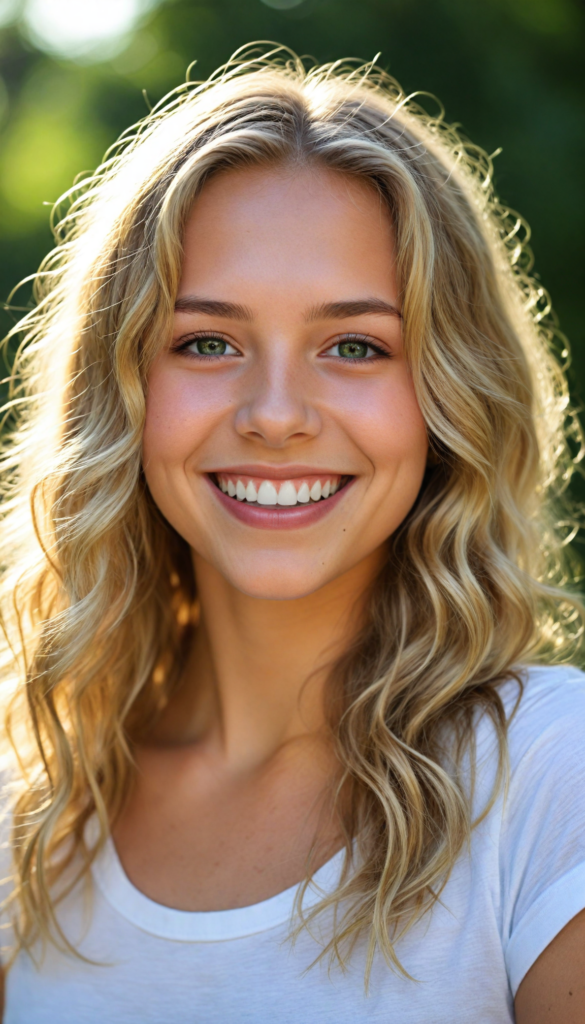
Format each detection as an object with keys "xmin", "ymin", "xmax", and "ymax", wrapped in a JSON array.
[{"xmin": 5, "ymin": 168, "xmax": 585, "ymax": 1024}]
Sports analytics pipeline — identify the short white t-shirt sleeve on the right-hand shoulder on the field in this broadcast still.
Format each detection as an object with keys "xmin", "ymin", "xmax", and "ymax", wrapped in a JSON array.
[{"xmin": 500, "ymin": 668, "xmax": 585, "ymax": 995}]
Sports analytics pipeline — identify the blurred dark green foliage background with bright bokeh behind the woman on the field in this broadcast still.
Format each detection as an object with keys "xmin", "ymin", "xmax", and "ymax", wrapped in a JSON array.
[{"xmin": 0, "ymin": 0, "xmax": 585, "ymax": 456}]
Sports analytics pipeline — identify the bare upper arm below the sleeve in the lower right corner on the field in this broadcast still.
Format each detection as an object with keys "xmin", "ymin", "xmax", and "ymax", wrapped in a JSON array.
[{"xmin": 514, "ymin": 910, "xmax": 585, "ymax": 1024}]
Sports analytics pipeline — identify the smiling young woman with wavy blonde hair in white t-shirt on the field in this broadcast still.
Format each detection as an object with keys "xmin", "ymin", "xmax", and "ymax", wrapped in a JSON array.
[{"xmin": 2, "ymin": 46, "xmax": 585, "ymax": 1024}]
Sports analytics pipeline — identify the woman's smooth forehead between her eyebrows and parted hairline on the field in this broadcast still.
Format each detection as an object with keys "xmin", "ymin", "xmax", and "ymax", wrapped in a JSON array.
[{"xmin": 181, "ymin": 165, "xmax": 395, "ymax": 300}]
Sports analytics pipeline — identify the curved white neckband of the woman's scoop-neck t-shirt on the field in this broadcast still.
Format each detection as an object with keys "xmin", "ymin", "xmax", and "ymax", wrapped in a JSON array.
[{"xmin": 92, "ymin": 837, "xmax": 345, "ymax": 942}]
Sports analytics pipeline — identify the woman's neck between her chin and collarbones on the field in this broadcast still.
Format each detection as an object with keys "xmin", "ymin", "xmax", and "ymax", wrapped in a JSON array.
[{"xmin": 155, "ymin": 551, "xmax": 382, "ymax": 766}]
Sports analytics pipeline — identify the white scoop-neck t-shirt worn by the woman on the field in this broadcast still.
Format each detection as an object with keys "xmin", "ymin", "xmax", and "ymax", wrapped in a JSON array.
[{"xmin": 1, "ymin": 668, "xmax": 585, "ymax": 1024}]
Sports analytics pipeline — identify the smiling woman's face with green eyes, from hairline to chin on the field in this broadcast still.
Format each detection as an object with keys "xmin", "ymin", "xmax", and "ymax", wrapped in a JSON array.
[{"xmin": 143, "ymin": 161, "xmax": 427, "ymax": 599}]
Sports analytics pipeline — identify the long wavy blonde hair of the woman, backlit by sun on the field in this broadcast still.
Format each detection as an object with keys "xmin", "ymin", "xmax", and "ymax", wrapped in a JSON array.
[{"xmin": 0, "ymin": 46, "xmax": 581, "ymax": 968}]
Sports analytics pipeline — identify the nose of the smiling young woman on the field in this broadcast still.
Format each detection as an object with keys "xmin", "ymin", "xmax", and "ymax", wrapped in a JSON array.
[{"xmin": 236, "ymin": 358, "xmax": 321, "ymax": 449}]
